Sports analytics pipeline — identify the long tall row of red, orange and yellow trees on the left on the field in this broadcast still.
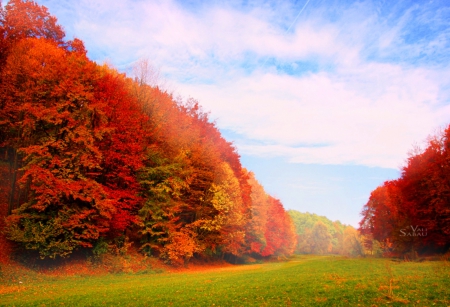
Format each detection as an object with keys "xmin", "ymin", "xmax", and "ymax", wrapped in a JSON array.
[{"xmin": 0, "ymin": 0, "xmax": 296, "ymax": 263}]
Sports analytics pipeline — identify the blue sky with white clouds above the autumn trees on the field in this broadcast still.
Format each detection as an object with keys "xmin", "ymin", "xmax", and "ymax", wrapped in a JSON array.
[{"xmin": 31, "ymin": 0, "xmax": 450, "ymax": 226}]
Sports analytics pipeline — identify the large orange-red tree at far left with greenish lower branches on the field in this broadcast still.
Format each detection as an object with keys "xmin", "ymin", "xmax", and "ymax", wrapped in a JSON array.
[{"xmin": 0, "ymin": 39, "xmax": 114, "ymax": 257}]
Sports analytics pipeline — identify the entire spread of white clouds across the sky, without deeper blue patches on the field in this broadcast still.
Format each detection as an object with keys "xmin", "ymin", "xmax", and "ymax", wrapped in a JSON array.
[{"xmin": 37, "ymin": 0, "xmax": 450, "ymax": 168}]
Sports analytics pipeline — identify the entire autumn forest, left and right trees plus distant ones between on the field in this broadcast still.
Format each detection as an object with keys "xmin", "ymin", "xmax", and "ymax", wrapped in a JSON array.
[{"xmin": 0, "ymin": 0, "xmax": 450, "ymax": 272}]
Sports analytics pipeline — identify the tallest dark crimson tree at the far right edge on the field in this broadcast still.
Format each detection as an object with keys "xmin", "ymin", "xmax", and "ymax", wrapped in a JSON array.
[{"xmin": 401, "ymin": 126, "xmax": 450, "ymax": 250}]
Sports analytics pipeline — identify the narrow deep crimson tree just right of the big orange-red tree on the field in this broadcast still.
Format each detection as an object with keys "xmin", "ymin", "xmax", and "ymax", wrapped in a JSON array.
[{"xmin": 94, "ymin": 67, "xmax": 145, "ymax": 232}]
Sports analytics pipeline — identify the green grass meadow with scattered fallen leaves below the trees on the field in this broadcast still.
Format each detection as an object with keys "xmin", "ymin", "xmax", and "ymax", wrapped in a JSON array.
[{"xmin": 0, "ymin": 256, "xmax": 450, "ymax": 306}]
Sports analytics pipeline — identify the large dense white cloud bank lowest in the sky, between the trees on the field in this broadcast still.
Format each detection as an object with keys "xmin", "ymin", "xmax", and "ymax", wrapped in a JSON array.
[{"xmin": 174, "ymin": 60, "xmax": 444, "ymax": 168}]
